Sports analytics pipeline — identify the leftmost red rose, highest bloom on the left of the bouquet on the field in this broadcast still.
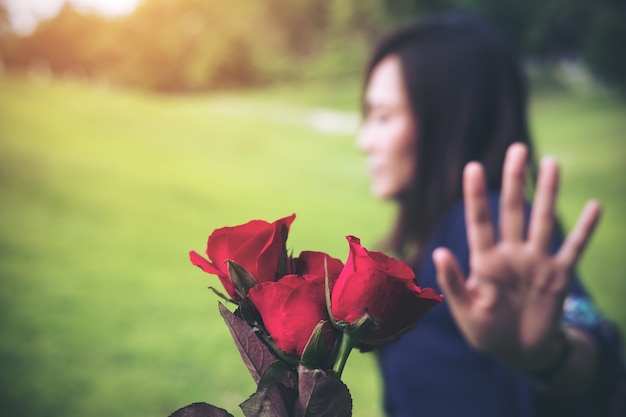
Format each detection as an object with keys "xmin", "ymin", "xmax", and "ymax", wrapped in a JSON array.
[{"xmin": 189, "ymin": 214, "xmax": 296, "ymax": 300}]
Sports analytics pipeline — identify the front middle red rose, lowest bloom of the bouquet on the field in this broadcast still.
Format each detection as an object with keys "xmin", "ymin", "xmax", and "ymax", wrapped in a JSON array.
[{"xmin": 248, "ymin": 274, "xmax": 335, "ymax": 358}]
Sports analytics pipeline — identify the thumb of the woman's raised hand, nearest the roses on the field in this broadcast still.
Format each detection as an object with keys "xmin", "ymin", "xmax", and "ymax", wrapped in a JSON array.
[{"xmin": 433, "ymin": 248, "xmax": 468, "ymax": 306}]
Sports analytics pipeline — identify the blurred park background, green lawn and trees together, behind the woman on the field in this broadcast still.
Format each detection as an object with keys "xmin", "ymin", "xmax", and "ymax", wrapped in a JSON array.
[{"xmin": 0, "ymin": 0, "xmax": 626, "ymax": 417}]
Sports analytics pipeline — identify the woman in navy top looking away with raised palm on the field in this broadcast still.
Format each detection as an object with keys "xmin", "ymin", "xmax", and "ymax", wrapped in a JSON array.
[{"xmin": 358, "ymin": 15, "xmax": 620, "ymax": 417}]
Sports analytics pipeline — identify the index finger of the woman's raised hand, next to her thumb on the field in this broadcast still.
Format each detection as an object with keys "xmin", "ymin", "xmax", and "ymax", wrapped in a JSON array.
[{"xmin": 463, "ymin": 162, "xmax": 494, "ymax": 251}]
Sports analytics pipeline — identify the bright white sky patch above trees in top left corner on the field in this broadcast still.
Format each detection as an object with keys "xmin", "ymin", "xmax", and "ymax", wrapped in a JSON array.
[{"xmin": 0, "ymin": 0, "xmax": 142, "ymax": 33}]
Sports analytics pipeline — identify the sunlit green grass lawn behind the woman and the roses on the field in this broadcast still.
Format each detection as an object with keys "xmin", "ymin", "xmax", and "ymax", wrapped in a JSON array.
[{"xmin": 0, "ymin": 77, "xmax": 626, "ymax": 417}]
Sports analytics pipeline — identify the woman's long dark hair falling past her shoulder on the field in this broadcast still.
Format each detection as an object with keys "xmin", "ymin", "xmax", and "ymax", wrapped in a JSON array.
[{"xmin": 365, "ymin": 14, "xmax": 535, "ymax": 258}]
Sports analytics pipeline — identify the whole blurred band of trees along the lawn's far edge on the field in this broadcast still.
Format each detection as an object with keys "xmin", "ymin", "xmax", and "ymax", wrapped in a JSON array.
[{"xmin": 0, "ymin": 0, "xmax": 626, "ymax": 92}]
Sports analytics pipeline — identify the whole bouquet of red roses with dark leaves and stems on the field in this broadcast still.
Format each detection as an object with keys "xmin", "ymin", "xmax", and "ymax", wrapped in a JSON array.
[{"xmin": 171, "ymin": 214, "xmax": 443, "ymax": 417}]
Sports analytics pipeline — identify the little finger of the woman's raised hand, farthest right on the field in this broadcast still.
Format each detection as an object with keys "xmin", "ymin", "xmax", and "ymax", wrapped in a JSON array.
[{"xmin": 556, "ymin": 200, "xmax": 602, "ymax": 269}]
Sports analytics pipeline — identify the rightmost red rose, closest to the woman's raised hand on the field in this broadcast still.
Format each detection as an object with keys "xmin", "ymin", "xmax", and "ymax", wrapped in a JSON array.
[{"xmin": 331, "ymin": 236, "xmax": 443, "ymax": 342}]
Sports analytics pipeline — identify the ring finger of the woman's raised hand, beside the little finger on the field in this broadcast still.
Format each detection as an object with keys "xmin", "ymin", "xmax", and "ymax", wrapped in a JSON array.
[{"xmin": 528, "ymin": 158, "xmax": 559, "ymax": 251}]
